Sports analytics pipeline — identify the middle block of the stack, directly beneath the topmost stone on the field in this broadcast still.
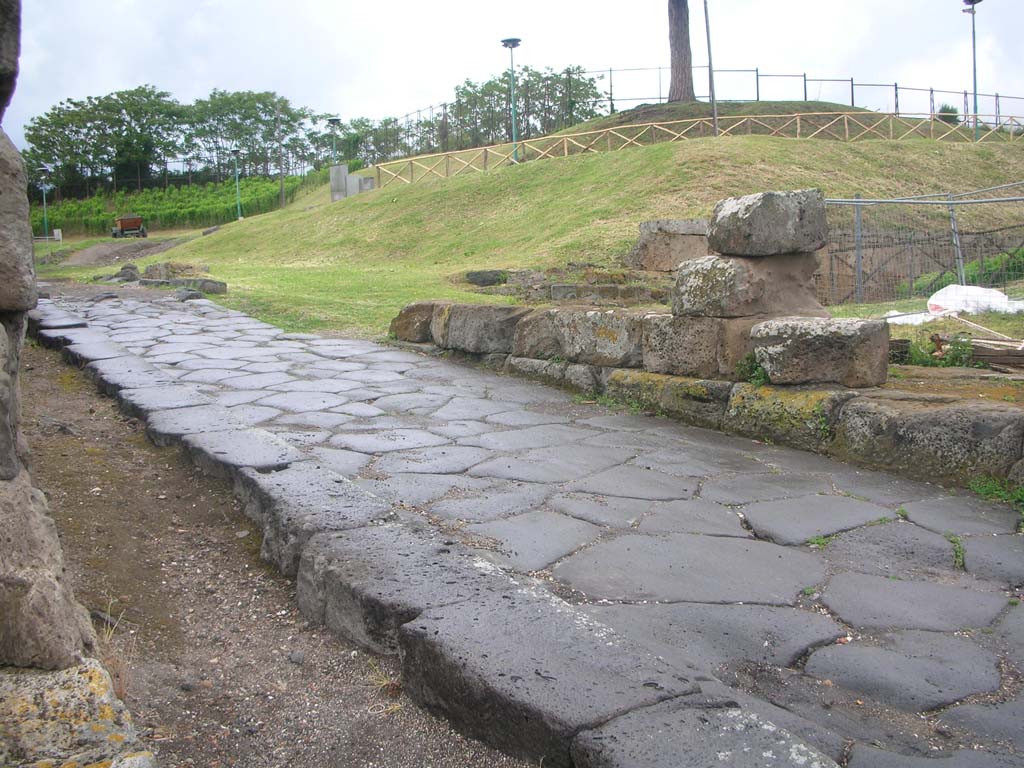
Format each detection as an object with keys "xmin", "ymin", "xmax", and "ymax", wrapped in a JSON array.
[{"xmin": 672, "ymin": 253, "xmax": 828, "ymax": 317}]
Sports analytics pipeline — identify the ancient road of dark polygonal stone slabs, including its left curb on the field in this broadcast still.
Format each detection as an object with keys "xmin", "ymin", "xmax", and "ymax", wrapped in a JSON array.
[{"xmin": 36, "ymin": 298, "xmax": 1024, "ymax": 768}]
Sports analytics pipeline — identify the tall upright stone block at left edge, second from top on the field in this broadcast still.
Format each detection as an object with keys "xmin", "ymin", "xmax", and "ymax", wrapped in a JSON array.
[{"xmin": 0, "ymin": 130, "xmax": 37, "ymax": 311}]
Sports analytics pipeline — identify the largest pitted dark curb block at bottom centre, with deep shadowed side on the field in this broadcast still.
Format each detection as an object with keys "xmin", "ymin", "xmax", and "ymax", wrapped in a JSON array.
[{"xmin": 399, "ymin": 588, "xmax": 699, "ymax": 768}]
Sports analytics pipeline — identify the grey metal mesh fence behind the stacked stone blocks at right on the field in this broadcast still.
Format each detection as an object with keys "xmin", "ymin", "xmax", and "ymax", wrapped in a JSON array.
[{"xmin": 815, "ymin": 181, "xmax": 1024, "ymax": 304}]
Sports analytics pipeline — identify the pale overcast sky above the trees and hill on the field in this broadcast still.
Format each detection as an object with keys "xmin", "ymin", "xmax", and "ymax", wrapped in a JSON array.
[{"xmin": 4, "ymin": 0, "xmax": 1024, "ymax": 146}]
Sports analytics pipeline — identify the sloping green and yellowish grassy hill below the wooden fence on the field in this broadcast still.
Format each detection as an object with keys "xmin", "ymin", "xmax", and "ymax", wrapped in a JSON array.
[{"xmin": 40, "ymin": 136, "xmax": 1024, "ymax": 336}]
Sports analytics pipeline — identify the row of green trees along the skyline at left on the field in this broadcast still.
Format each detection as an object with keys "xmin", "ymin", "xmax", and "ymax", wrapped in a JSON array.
[{"xmin": 24, "ymin": 67, "xmax": 603, "ymax": 199}]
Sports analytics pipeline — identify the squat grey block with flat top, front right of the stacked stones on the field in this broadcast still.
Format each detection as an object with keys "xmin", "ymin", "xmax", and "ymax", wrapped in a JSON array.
[{"xmin": 751, "ymin": 317, "xmax": 889, "ymax": 387}]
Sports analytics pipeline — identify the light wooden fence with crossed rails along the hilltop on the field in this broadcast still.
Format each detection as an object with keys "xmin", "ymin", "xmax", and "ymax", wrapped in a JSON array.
[{"xmin": 374, "ymin": 112, "xmax": 1024, "ymax": 188}]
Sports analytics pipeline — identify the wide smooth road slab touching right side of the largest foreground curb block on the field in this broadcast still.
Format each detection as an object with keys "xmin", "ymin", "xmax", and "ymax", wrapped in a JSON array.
[{"xmin": 586, "ymin": 603, "xmax": 846, "ymax": 670}]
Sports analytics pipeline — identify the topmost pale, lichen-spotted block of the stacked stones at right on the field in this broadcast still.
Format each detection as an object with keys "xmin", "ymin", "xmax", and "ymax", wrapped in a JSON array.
[{"xmin": 708, "ymin": 189, "xmax": 828, "ymax": 256}]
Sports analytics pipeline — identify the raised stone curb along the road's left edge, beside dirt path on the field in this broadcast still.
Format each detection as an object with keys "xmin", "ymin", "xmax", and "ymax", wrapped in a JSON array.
[{"xmin": 34, "ymin": 302, "xmax": 836, "ymax": 768}]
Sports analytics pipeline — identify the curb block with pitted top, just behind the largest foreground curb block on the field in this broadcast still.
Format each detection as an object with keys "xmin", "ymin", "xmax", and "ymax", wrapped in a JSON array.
[{"xmin": 298, "ymin": 523, "xmax": 514, "ymax": 653}]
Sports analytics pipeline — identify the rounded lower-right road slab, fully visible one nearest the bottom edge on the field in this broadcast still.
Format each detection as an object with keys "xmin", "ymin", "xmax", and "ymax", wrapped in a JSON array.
[{"xmin": 806, "ymin": 630, "xmax": 999, "ymax": 712}]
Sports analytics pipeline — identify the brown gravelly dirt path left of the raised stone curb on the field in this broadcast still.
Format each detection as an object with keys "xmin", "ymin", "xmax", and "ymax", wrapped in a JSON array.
[{"xmin": 23, "ymin": 342, "xmax": 524, "ymax": 768}]
